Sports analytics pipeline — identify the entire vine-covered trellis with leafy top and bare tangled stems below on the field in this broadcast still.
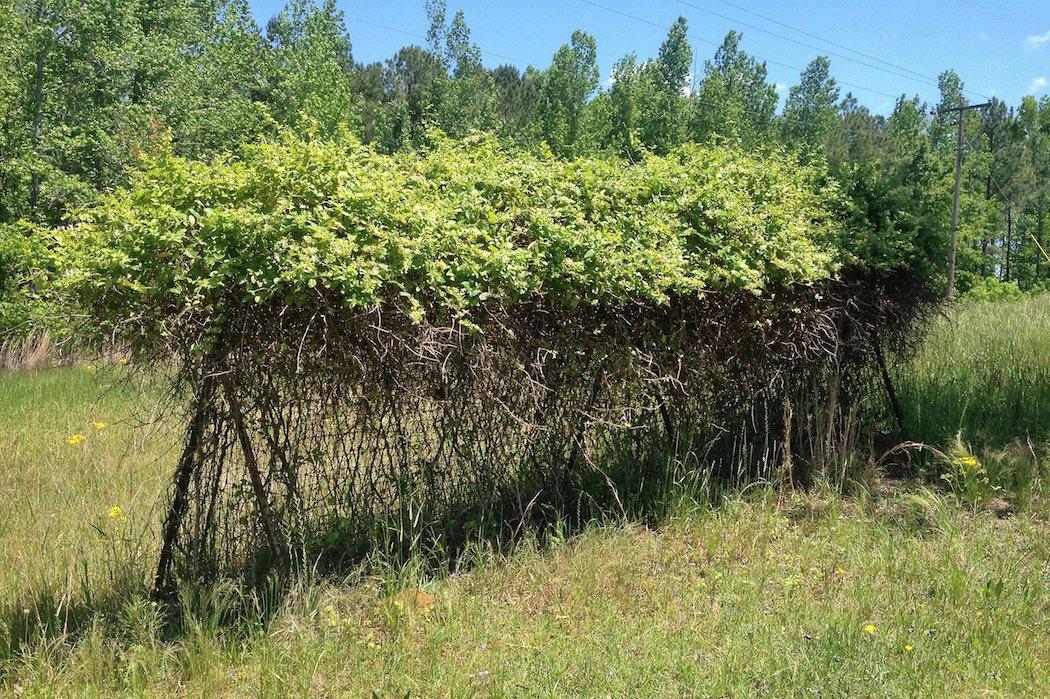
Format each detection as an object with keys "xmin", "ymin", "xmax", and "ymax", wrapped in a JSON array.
[{"xmin": 61, "ymin": 132, "xmax": 930, "ymax": 591}]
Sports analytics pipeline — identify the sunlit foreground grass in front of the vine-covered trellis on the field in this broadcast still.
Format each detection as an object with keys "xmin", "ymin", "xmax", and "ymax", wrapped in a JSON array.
[{"xmin": 2, "ymin": 482, "xmax": 1050, "ymax": 696}]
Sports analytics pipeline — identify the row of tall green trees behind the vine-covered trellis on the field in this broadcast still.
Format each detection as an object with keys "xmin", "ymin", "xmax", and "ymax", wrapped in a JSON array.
[{"xmin": 0, "ymin": 0, "xmax": 1050, "ymax": 295}]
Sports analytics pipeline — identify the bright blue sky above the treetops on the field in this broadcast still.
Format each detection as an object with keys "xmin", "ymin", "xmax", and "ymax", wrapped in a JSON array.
[{"xmin": 251, "ymin": 0, "xmax": 1050, "ymax": 113}]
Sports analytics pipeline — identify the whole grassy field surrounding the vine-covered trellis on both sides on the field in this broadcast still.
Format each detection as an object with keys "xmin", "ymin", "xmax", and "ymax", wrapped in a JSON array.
[{"xmin": 0, "ymin": 299, "xmax": 1050, "ymax": 696}]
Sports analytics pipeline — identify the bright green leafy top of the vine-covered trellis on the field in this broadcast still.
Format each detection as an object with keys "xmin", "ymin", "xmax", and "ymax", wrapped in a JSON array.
[{"xmin": 66, "ymin": 137, "xmax": 860, "ymax": 335}]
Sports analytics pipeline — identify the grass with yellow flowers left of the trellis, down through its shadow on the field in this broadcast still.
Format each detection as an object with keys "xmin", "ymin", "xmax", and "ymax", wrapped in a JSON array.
[{"xmin": 0, "ymin": 365, "xmax": 173, "ymax": 663}]
